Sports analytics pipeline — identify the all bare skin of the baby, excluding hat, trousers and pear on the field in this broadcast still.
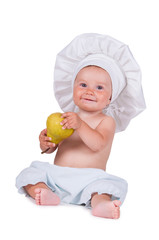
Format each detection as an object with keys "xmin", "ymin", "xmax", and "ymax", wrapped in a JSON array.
[{"xmin": 24, "ymin": 66, "xmax": 121, "ymax": 218}]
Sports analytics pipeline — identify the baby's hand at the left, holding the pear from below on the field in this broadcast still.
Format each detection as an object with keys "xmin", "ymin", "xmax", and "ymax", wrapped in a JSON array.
[{"xmin": 39, "ymin": 129, "xmax": 56, "ymax": 151}]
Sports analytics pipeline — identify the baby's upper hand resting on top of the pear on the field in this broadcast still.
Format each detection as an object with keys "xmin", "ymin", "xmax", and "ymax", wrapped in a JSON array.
[{"xmin": 60, "ymin": 112, "xmax": 82, "ymax": 129}]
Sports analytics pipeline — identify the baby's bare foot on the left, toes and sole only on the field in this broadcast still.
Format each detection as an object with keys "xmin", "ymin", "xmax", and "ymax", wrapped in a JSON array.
[{"xmin": 35, "ymin": 188, "xmax": 60, "ymax": 205}]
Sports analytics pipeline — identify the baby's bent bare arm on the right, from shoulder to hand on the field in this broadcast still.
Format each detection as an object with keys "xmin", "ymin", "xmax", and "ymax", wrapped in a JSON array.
[{"xmin": 62, "ymin": 113, "xmax": 115, "ymax": 151}]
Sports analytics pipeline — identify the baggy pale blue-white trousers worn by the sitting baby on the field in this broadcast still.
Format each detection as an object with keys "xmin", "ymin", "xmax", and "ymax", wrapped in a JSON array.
[{"xmin": 16, "ymin": 161, "xmax": 128, "ymax": 207}]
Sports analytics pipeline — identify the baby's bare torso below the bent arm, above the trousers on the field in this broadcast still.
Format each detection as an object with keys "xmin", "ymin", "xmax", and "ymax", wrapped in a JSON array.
[{"xmin": 55, "ymin": 132, "xmax": 110, "ymax": 170}]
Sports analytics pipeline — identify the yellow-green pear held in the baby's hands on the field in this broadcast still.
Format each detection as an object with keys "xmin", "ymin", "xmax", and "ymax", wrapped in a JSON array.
[{"xmin": 46, "ymin": 113, "xmax": 74, "ymax": 144}]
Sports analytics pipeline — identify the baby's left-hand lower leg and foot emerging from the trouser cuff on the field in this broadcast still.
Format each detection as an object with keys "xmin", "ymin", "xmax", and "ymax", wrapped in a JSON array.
[{"xmin": 24, "ymin": 182, "xmax": 60, "ymax": 205}]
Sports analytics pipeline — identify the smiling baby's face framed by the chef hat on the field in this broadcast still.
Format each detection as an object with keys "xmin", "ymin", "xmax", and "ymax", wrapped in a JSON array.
[{"xmin": 73, "ymin": 66, "xmax": 112, "ymax": 111}]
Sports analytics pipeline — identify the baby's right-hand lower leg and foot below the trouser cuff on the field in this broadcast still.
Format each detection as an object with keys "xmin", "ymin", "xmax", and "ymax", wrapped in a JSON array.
[{"xmin": 91, "ymin": 193, "xmax": 121, "ymax": 219}]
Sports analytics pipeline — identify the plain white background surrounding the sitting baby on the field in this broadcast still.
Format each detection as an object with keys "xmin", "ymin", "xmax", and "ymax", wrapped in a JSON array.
[{"xmin": 0, "ymin": 0, "xmax": 159, "ymax": 240}]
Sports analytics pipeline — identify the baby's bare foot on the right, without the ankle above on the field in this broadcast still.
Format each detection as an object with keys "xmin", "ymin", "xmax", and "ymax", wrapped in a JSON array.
[{"xmin": 92, "ymin": 200, "xmax": 121, "ymax": 219}]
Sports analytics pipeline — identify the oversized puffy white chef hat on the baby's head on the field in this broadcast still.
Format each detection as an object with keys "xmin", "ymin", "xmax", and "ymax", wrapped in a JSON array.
[{"xmin": 54, "ymin": 33, "xmax": 146, "ymax": 132}]
